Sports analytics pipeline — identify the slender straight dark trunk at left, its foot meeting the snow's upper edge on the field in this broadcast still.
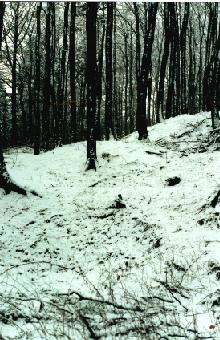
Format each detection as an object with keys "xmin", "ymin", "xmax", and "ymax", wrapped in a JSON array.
[{"xmin": 34, "ymin": 2, "xmax": 42, "ymax": 155}]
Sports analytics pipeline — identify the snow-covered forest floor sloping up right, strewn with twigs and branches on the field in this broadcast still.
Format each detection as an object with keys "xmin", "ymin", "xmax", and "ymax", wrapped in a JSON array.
[{"xmin": 0, "ymin": 113, "xmax": 220, "ymax": 339}]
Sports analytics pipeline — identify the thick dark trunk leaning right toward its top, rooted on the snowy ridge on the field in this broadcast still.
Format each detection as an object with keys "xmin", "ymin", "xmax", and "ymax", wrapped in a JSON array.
[{"xmin": 136, "ymin": 3, "xmax": 158, "ymax": 140}]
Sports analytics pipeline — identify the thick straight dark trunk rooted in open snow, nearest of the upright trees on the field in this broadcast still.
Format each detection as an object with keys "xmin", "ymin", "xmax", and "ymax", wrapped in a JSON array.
[{"xmin": 86, "ymin": 2, "xmax": 98, "ymax": 170}]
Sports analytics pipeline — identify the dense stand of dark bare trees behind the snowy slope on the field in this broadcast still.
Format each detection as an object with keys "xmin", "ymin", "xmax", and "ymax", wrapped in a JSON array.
[{"xmin": 0, "ymin": 2, "xmax": 220, "ymax": 175}]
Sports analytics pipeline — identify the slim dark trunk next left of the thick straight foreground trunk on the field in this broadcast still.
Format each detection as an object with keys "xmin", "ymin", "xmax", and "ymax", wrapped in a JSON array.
[{"xmin": 69, "ymin": 2, "xmax": 77, "ymax": 142}]
